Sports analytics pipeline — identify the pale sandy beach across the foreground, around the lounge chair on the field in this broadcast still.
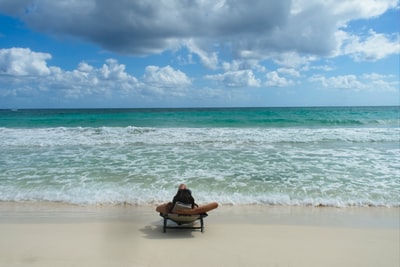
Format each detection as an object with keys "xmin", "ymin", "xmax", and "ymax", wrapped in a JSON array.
[{"xmin": 0, "ymin": 202, "xmax": 400, "ymax": 267}]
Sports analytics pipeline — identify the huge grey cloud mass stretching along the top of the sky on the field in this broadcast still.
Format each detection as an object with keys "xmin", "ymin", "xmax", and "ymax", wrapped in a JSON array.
[{"xmin": 0, "ymin": 0, "xmax": 396, "ymax": 63}]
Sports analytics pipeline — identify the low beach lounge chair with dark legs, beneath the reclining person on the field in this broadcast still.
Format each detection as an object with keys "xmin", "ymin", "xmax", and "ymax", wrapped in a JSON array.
[{"xmin": 160, "ymin": 202, "xmax": 208, "ymax": 233}]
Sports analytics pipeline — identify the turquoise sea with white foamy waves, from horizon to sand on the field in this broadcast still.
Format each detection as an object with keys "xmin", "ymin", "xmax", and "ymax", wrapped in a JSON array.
[{"xmin": 0, "ymin": 107, "xmax": 400, "ymax": 207}]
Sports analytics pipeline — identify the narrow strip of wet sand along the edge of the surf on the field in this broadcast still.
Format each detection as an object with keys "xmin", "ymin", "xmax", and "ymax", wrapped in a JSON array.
[{"xmin": 0, "ymin": 201, "xmax": 400, "ymax": 228}]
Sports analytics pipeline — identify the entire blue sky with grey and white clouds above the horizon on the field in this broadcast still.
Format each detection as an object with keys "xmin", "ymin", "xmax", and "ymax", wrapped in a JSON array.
[{"xmin": 0, "ymin": 0, "xmax": 400, "ymax": 108}]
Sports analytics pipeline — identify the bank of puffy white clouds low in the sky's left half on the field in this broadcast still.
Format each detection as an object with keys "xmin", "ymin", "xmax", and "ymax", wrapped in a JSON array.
[{"xmin": 0, "ymin": 48, "xmax": 197, "ymax": 101}]
